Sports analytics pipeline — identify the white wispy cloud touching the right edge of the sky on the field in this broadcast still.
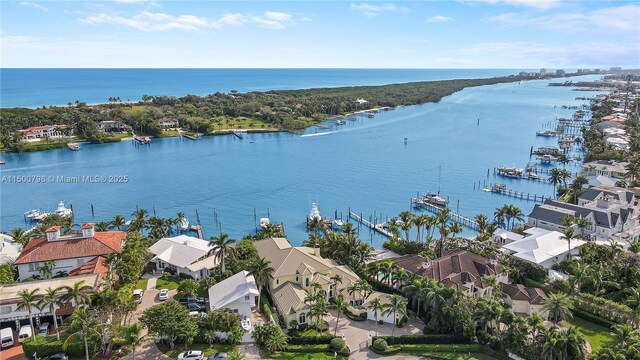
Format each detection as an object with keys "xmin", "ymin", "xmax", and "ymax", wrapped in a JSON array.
[{"xmin": 487, "ymin": 4, "xmax": 640, "ymax": 34}]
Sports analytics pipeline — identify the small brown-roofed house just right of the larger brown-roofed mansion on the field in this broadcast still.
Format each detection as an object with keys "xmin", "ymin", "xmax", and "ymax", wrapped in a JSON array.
[{"xmin": 500, "ymin": 283, "xmax": 549, "ymax": 319}]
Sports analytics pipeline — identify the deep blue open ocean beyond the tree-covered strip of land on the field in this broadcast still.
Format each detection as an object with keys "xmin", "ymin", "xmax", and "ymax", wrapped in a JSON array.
[{"xmin": 0, "ymin": 69, "xmax": 520, "ymax": 107}]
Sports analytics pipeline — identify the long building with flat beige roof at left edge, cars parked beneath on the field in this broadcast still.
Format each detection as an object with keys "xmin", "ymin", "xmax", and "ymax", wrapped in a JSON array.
[{"xmin": 0, "ymin": 274, "xmax": 100, "ymax": 330}]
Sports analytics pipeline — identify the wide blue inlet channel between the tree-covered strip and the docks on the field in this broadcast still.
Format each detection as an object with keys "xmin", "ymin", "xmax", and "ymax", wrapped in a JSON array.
[{"xmin": 0, "ymin": 76, "xmax": 592, "ymax": 247}]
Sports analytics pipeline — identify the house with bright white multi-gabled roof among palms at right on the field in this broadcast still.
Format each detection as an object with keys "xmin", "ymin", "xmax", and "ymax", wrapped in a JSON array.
[{"xmin": 502, "ymin": 227, "xmax": 585, "ymax": 269}]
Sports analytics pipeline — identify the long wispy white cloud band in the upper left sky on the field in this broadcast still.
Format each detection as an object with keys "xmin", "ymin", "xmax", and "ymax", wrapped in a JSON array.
[{"xmin": 79, "ymin": 11, "xmax": 295, "ymax": 31}]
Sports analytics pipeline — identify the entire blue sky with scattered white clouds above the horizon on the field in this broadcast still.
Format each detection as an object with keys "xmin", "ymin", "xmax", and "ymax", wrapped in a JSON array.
[{"xmin": 0, "ymin": 0, "xmax": 640, "ymax": 68}]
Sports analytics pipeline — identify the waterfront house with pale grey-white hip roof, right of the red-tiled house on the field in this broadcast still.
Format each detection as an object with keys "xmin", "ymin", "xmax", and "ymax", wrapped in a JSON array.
[{"xmin": 149, "ymin": 235, "xmax": 218, "ymax": 280}]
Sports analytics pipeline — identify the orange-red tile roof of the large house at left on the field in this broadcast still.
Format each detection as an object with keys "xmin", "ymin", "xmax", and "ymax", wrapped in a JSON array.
[{"xmin": 14, "ymin": 231, "xmax": 127, "ymax": 265}]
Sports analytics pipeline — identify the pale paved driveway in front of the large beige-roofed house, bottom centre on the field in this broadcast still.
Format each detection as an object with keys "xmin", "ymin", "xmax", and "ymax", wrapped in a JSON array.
[{"xmin": 324, "ymin": 310, "xmax": 424, "ymax": 359}]
